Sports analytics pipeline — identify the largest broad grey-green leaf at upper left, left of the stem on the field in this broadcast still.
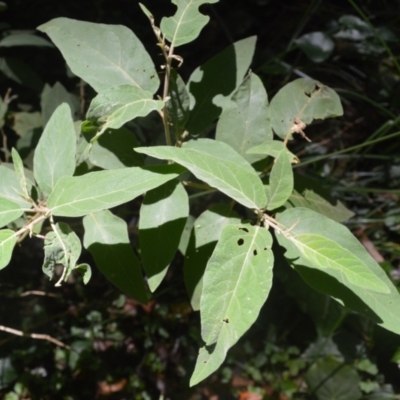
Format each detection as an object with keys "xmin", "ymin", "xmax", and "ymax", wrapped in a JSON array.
[{"xmin": 37, "ymin": 18, "xmax": 160, "ymax": 93}]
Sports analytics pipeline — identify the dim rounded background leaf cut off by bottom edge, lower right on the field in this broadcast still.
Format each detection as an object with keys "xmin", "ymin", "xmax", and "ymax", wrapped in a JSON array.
[{"xmin": 305, "ymin": 357, "xmax": 362, "ymax": 400}]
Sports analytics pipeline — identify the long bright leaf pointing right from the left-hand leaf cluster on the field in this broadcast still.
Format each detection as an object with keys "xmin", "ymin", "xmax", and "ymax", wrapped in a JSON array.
[{"xmin": 47, "ymin": 165, "xmax": 185, "ymax": 217}]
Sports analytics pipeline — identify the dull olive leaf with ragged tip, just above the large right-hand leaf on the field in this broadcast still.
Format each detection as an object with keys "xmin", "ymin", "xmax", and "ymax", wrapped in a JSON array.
[{"xmin": 285, "ymin": 174, "xmax": 354, "ymax": 222}]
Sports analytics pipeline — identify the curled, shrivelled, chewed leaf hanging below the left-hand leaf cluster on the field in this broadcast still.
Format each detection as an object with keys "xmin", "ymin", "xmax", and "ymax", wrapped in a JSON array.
[{"xmin": 42, "ymin": 222, "xmax": 82, "ymax": 286}]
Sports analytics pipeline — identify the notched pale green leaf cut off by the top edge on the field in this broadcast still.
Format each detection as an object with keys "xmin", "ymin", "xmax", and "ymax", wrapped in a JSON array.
[{"xmin": 160, "ymin": 0, "xmax": 219, "ymax": 47}]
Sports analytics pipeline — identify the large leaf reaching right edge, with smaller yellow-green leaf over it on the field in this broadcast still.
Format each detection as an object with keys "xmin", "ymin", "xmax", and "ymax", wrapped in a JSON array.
[{"xmin": 276, "ymin": 207, "xmax": 400, "ymax": 334}]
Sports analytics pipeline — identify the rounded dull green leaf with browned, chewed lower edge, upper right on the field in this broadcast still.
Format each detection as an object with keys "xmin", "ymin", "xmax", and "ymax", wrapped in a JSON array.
[{"xmin": 270, "ymin": 78, "xmax": 343, "ymax": 139}]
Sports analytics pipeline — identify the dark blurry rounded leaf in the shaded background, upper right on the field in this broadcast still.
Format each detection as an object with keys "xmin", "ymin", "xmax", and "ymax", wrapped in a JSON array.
[{"xmin": 295, "ymin": 32, "xmax": 335, "ymax": 63}]
